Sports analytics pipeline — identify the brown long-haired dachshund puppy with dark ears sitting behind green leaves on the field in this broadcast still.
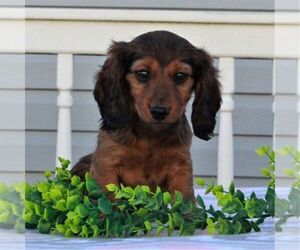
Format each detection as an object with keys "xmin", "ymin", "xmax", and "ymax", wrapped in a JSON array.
[{"xmin": 72, "ymin": 31, "xmax": 221, "ymax": 199}]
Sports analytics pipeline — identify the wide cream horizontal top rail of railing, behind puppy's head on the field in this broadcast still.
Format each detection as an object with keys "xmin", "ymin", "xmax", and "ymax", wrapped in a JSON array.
[{"xmin": 0, "ymin": 7, "xmax": 300, "ymax": 59}]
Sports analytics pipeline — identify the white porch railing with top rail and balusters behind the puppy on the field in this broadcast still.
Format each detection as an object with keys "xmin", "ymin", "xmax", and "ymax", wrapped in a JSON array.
[{"xmin": 0, "ymin": 8, "xmax": 300, "ymax": 186}]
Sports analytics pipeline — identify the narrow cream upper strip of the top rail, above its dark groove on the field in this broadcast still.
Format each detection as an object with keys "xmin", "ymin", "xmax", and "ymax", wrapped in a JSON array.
[{"xmin": 0, "ymin": 7, "xmax": 300, "ymax": 25}]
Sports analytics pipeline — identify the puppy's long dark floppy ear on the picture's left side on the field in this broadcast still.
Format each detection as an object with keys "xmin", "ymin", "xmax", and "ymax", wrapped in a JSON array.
[{"xmin": 93, "ymin": 42, "xmax": 133, "ymax": 130}]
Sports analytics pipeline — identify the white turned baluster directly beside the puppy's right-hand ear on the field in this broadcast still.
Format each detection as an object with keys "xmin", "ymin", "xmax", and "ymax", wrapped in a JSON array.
[{"xmin": 218, "ymin": 57, "xmax": 234, "ymax": 187}]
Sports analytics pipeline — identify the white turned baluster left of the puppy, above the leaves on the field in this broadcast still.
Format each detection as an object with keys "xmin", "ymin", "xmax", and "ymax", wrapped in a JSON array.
[{"xmin": 56, "ymin": 54, "xmax": 73, "ymax": 166}]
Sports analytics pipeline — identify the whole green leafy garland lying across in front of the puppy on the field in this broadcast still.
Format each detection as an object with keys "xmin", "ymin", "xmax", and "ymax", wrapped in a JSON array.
[{"xmin": 0, "ymin": 147, "xmax": 300, "ymax": 237}]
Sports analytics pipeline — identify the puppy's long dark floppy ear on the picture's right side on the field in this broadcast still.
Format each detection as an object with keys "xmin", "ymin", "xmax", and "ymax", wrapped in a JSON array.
[{"xmin": 191, "ymin": 49, "xmax": 222, "ymax": 140}]
